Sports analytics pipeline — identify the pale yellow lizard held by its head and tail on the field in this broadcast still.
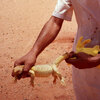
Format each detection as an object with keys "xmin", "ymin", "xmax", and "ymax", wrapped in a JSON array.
[{"xmin": 14, "ymin": 53, "xmax": 68, "ymax": 86}]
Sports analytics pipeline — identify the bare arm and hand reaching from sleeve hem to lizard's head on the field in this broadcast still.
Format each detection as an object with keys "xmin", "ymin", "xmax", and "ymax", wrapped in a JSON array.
[{"xmin": 12, "ymin": 16, "xmax": 63, "ymax": 77}]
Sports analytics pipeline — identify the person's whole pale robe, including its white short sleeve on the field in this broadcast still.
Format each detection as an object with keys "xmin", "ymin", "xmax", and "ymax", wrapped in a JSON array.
[{"xmin": 53, "ymin": 0, "xmax": 100, "ymax": 100}]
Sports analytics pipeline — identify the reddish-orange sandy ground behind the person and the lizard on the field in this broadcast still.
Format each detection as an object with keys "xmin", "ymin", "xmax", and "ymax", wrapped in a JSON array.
[{"xmin": 0, "ymin": 0, "xmax": 77, "ymax": 100}]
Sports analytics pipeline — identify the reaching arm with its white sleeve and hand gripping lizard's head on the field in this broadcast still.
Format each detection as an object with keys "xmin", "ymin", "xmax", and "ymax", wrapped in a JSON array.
[{"xmin": 13, "ymin": 0, "xmax": 73, "ymax": 76}]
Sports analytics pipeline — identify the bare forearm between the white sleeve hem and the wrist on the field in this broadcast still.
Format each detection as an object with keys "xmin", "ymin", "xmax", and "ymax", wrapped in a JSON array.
[{"xmin": 31, "ymin": 17, "xmax": 63, "ymax": 56}]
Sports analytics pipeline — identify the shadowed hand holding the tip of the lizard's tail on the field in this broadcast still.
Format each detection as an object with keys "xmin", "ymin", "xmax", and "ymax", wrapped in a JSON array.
[{"xmin": 65, "ymin": 52, "xmax": 100, "ymax": 69}]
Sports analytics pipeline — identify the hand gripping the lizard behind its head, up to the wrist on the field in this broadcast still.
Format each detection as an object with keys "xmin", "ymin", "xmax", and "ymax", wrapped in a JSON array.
[{"xmin": 12, "ymin": 52, "xmax": 36, "ymax": 79}]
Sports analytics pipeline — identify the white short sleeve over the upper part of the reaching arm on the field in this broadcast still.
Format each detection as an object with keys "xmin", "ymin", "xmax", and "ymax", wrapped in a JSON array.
[{"xmin": 53, "ymin": 0, "xmax": 73, "ymax": 21}]
